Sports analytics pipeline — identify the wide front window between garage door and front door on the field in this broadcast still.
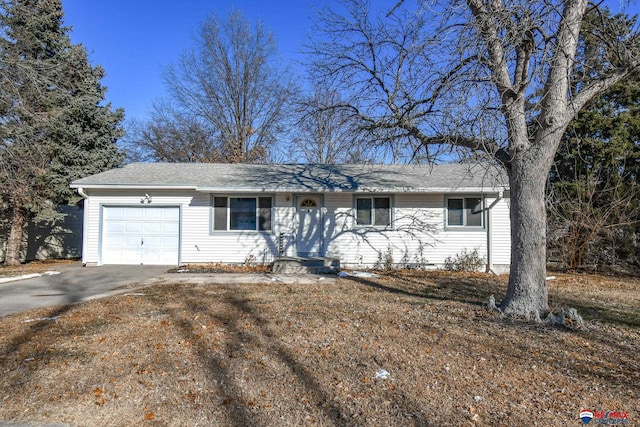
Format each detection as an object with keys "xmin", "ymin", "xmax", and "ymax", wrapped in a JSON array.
[{"xmin": 213, "ymin": 196, "xmax": 272, "ymax": 231}]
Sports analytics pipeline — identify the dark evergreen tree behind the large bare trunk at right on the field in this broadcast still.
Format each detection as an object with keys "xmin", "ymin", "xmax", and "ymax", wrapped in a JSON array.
[{"xmin": 548, "ymin": 10, "xmax": 640, "ymax": 269}]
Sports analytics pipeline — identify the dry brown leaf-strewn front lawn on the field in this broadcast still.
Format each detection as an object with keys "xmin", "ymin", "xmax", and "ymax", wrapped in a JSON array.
[{"xmin": 0, "ymin": 272, "xmax": 640, "ymax": 426}]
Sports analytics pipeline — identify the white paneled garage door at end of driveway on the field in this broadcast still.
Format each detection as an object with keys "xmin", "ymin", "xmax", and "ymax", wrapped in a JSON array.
[{"xmin": 102, "ymin": 206, "xmax": 180, "ymax": 265}]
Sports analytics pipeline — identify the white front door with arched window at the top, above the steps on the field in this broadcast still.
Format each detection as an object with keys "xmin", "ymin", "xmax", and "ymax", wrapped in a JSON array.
[{"xmin": 296, "ymin": 196, "xmax": 322, "ymax": 256}]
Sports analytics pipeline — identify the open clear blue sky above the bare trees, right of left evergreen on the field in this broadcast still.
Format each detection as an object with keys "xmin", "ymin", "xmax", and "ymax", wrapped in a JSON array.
[{"xmin": 62, "ymin": 0, "xmax": 324, "ymax": 120}]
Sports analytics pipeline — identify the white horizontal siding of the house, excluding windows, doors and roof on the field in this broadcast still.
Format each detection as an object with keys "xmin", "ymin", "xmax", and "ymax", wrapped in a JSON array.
[{"xmin": 83, "ymin": 190, "xmax": 510, "ymax": 272}]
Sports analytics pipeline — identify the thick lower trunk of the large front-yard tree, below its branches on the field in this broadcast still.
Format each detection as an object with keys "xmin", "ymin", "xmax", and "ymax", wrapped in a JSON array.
[{"xmin": 500, "ymin": 156, "xmax": 549, "ymax": 319}]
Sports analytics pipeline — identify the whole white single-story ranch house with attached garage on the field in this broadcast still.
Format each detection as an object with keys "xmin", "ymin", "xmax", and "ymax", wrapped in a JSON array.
[{"xmin": 72, "ymin": 163, "xmax": 510, "ymax": 272}]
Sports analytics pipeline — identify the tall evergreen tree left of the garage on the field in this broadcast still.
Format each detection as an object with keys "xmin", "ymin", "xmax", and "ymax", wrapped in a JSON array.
[{"xmin": 0, "ymin": 0, "xmax": 124, "ymax": 264}]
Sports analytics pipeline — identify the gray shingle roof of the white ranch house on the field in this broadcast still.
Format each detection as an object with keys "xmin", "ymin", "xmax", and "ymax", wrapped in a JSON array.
[{"xmin": 71, "ymin": 163, "xmax": 507, "ymax": 192}]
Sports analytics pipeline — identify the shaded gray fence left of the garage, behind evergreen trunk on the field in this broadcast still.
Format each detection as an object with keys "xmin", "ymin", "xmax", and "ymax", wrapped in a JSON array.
[{"xmin": 0, "ymin": 206, "xmax": 83, "ymax": 261}]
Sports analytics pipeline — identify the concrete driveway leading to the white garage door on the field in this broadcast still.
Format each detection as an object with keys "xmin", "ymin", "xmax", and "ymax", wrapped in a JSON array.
[{"xmin": 0, "ymin": 262, "xmax": 171, "ymax": 317}]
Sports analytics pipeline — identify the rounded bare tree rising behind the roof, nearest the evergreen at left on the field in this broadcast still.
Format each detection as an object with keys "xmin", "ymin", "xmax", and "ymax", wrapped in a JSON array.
[{"xmin": 128, "ymin": 12, "xmax": 293, "ymax": 163}]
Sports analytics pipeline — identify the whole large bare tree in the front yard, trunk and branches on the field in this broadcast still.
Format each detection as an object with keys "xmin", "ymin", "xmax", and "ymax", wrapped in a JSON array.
[{"xmin": 312, "ymin": 0, "xmax": 640, "ymax": 318}]
